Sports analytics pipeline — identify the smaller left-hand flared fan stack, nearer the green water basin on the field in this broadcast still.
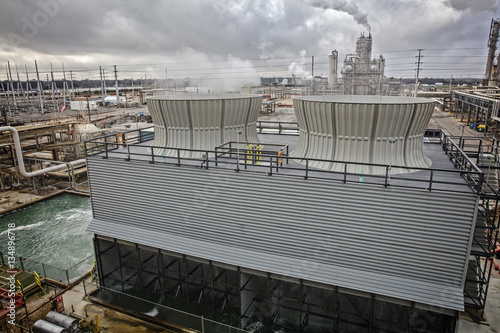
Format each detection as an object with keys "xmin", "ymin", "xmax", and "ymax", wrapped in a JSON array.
[{"xmin": 147, "ymin": 94, "xmax": 262, "ymax": 157}]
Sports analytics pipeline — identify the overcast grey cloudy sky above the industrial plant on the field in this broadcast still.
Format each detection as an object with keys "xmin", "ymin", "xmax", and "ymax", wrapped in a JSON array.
[{"xmin": 0, "ymin": 0, "xmax": 500, "ymax": 88}]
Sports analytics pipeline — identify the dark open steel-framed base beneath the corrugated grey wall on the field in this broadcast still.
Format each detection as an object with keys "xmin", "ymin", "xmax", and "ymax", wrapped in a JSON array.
[{"xmin": 94, "ymin": 236, "xmax": 456, "ymax": 333}]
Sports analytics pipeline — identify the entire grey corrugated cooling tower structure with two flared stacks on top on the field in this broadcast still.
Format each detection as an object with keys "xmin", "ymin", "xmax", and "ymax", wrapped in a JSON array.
[{"xmin": 86, "ymin": 94, "xmax": 498, "ymax": 332}]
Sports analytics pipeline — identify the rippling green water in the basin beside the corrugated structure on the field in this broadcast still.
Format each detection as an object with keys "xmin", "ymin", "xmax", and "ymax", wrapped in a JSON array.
[{"xmin": 0, "ymin": 193, "xmax": 93, "ymax": 269}]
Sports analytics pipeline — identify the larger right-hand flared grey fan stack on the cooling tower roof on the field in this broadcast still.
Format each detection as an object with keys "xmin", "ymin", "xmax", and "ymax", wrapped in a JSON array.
[{"xmin": 292, "ymin": 95, "xmax": 434, "ymax": 174}]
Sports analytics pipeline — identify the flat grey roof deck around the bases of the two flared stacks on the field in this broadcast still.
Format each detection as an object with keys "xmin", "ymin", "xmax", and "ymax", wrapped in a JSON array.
[{"xmin": 87, "ymin": 130, "xmax": 482, "ymax": 193}]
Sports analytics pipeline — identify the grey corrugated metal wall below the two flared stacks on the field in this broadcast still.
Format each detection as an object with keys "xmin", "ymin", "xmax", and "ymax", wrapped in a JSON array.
[{"xmin": 87, "ymin": 157, "xmax": 477, "ymax": 310}]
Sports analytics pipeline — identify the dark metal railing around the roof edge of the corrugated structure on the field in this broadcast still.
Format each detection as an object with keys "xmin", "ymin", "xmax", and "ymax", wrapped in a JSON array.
[{"xmin": 85, "ymin": 126, "xmax": 484, "ymax": 194}]
